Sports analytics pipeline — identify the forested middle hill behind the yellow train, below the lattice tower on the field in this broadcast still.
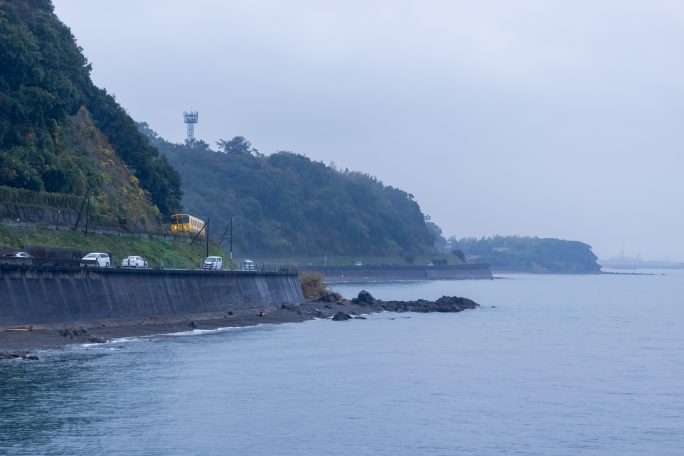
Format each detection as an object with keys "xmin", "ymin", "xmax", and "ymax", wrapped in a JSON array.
[{"xmin": 141, "ymin": 124, "xmax": 434, "ymax": 256}]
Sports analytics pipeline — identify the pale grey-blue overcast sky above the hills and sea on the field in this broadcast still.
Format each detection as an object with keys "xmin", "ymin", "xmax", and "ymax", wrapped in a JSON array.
[{"xmin": 54, "ymin": 0, "xmax": 684, "ymax": 261}]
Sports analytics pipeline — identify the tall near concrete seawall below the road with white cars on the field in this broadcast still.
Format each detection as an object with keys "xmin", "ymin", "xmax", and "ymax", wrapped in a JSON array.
[{"xmin": 0, "ymin": 265, "xmax": 304, "ymax": 326}]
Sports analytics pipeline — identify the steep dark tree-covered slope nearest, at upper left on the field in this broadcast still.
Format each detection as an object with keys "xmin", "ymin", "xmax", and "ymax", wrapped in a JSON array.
[{"xmin": 0, "ymin": 0, "xmax": 181, "ymax": 228}]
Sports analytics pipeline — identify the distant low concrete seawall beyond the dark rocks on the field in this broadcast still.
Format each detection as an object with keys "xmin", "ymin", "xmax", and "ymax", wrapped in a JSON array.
[{"xmin": 299, "ymin": 264, "xmax": 492, "ymax": 283}]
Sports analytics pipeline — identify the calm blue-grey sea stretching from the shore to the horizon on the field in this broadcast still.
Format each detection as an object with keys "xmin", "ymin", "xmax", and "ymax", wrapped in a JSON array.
[{"xmin": 0, "ymin": 271, "xmax": 684, "ymax": 456}]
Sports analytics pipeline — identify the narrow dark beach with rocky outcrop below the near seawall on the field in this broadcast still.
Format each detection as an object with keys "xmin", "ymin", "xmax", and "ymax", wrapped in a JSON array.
[{"xmin": 0, "ymin": 291, "xmax": 479, "ymax": 360}]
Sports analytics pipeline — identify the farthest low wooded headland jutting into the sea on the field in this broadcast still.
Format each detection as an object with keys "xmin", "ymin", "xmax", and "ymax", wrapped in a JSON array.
[{"xmin": 460, "ymin": 236, "xmax": 601, "ymax": 273}]
